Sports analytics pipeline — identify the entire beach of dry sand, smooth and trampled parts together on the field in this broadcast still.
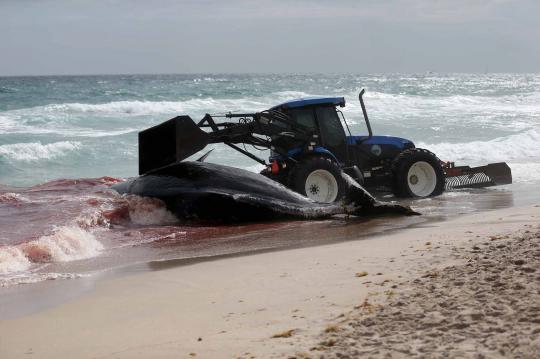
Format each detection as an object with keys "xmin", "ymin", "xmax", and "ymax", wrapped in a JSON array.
[{"xmin": 0, "ymin": 206, "xmax": 540, "ymax": 358}]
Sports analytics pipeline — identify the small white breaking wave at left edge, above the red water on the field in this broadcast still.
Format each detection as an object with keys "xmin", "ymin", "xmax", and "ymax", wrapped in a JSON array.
[{"xmin": 0, "ymin": 141, "xmax": 82, "ymax": 162}]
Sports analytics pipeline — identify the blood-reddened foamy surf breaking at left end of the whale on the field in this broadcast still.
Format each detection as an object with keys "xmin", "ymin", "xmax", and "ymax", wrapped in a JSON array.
[{"xmin": 0, "ymin": 186, "xmax": 178, "ymax": 285}]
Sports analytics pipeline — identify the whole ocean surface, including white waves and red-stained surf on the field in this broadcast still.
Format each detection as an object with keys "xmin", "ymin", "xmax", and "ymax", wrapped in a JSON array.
[{"xmin": 0, "ymin": 73, "xmax": 540, "ymax": 286}]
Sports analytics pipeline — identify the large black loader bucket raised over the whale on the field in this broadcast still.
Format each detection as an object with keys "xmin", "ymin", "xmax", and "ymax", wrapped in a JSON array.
[{"xmin": 139, "ymin": 116, "xmax": 210, "ymax": 175}]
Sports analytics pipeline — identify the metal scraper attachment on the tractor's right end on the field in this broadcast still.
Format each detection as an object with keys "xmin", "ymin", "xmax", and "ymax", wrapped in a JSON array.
[{"xmin": 444, "ymin": 162, "xmax": 512, "ymax": 190}]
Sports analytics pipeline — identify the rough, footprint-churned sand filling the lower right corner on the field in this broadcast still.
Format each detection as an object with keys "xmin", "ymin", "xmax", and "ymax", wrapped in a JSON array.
[{"xmin": 297, "ymin": 228, "xmax": 540, "ymax": 358}]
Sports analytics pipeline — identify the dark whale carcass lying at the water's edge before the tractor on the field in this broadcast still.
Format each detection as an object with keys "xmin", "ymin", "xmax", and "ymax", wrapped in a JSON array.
[{"xmin": 113, "ymin": 161, "xmax": 417, "ymax": 222}]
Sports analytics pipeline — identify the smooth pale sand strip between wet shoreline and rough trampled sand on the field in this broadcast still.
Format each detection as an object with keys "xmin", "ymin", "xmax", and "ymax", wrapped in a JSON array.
[{"xmin": 0, "ymin": 205, "xmax": 540, "ymax": 358}]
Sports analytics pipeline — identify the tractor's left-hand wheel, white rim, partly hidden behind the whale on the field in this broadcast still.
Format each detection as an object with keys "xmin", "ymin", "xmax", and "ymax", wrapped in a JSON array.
[{"xmin": 288, "ymin": 157, "xmax": 345, "ymax": 203}]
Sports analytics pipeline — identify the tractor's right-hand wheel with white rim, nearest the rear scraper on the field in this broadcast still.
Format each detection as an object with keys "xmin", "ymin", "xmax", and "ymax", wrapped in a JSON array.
[{"xmin": 392, "ymin": 148, "xmax": 445, "ymax": 197}]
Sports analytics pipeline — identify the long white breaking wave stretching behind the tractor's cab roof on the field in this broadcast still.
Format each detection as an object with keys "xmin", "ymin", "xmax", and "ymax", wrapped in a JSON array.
[{"xmin": 16, "ymin": 90, "xmax": 540, "ymax": 119}]
